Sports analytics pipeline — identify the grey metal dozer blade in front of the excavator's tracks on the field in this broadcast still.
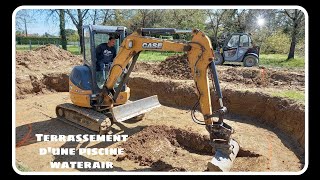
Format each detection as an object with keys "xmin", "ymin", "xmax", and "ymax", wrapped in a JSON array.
[{"xmin": 111, "ymin": 95, "xmax": 161, "ymax": 122}]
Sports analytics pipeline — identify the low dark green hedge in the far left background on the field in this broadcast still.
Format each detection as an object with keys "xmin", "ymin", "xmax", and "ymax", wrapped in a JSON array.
[{"xmin": 16, "ymin": 36, "xmax": 61, "ymax": 44}]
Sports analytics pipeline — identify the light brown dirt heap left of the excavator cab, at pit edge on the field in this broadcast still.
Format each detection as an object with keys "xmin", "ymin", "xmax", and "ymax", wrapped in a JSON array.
[{"xmin": 16, "ymin": 45, "xmax": 82, "ymax": 99}]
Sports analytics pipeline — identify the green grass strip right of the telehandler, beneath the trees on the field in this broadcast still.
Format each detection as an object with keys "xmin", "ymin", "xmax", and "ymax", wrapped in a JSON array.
[{"xmin": 259, "ymin": 54, "xmax": 305, "ymax": 68}]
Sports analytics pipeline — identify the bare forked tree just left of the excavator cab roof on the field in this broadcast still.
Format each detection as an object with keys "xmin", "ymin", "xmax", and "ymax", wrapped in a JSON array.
[{"xmin": 67, "ymin": 9, "xmax": 89, "ymax": 53}]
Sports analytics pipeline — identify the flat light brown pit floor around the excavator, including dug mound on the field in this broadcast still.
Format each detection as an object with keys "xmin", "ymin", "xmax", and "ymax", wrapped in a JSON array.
[{"xmin": 15, "ymin": 93, "xmax": 304, "ymax": 172}]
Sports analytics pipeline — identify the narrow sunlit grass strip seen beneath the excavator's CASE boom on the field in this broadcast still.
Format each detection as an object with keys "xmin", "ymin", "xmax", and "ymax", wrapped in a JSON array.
[{"xmin": 138, "ymin": 51, "xmax": 183, "ymax": 62}]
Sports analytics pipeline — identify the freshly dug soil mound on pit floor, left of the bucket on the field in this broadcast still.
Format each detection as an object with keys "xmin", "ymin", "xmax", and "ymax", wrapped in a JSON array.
[{"xmin": 117, "ymin": 125, "xmax": 213, "ymax": 171}]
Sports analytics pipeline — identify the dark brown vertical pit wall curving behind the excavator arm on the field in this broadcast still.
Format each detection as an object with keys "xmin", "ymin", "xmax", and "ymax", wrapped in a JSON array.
[{"xmin": 128, "ymin": 73, "xmax": 305, "ymax": 146}]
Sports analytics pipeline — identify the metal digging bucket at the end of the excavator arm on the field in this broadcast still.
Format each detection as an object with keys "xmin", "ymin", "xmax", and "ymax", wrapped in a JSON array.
[{"xmin": 208, "ymin": 139, "xmax": 239, "ymax": 172}]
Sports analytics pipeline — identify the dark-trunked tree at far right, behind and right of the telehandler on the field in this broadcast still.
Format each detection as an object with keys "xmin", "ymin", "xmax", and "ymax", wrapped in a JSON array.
[{"xmin": 284, "ymin": 9, "xmax": 304, "ymax": 60}]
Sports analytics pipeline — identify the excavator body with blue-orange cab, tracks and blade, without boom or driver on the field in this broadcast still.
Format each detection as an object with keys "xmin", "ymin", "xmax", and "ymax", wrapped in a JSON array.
[{"xmin": 56, "ymin": 25, "xmax": 160, "ymax": 134}]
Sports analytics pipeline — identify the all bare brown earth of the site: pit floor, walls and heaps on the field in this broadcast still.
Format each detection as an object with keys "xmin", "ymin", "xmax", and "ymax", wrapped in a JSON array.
[{"xmin": 16, "ymin": 45, "xmax": 305, "ymax": 172}]
